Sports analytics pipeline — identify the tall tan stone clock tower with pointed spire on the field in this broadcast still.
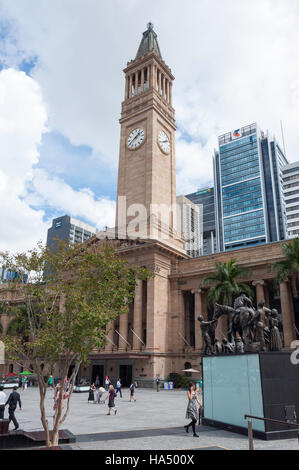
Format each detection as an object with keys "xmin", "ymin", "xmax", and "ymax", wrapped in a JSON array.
[{"xmin": 116, "ymin": 23, "xmax": 183, "ymax": 251}]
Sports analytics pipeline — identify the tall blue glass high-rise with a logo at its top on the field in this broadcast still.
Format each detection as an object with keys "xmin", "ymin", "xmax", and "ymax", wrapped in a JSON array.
[{"xmin": 214, "ymin": 124, "xmax": 288, "ymax": 251}]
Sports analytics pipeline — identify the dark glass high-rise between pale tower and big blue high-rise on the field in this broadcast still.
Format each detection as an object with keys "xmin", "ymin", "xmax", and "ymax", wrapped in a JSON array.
[{"xmin": 186, "ymin": 188, "xmax": 216, "ymax": 255}]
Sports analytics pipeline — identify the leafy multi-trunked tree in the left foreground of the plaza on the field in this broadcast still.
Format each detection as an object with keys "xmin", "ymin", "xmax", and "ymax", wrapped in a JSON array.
[{"xmin": 2, "ymin": 240, "xmax": 151, "ymax": 447}]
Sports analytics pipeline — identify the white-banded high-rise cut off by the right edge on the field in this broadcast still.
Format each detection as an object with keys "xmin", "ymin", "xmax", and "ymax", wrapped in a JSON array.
[{"xmin": 282, "ymin": 162, "xmax": 299, "ymax": 238}]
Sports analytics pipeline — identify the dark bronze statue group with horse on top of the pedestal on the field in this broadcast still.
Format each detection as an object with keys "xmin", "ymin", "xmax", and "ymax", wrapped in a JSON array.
[{"xmin": 198, "ymin": 293, "xmax": 282, "ymax": 355}]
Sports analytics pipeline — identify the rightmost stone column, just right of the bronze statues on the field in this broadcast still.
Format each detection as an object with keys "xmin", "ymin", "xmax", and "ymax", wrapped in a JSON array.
[{"xmin": 280, "ymin": 281, "xmax": 296, "ymax": 348}]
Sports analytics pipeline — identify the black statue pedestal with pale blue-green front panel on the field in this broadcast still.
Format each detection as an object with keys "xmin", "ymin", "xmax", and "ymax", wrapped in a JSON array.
[{"xmin": 202, "ymin": 351, "xmax": 299, "ymax": 440}]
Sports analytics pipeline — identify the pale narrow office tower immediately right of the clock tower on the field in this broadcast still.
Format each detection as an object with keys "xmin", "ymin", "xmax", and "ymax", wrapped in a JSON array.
[{"xmin": 176, "ymin": 196, "xmax": 203, "ymax": 258}]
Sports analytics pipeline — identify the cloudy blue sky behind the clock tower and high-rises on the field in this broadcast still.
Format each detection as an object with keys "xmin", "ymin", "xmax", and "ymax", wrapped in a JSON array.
[{"xmin": 0, "ymin": 0, "xmax": 299, "ymax": 249}]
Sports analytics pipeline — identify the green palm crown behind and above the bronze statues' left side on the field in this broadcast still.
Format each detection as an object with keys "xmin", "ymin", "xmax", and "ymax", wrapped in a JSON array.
[{"xmin": 201, "ymin": 258, "xmax": 252, "ymax": 307}]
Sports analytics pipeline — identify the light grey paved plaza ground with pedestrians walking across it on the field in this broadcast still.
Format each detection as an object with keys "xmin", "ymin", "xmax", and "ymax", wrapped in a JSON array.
[{"xmin": 2, "ymin": 388, "xmax": 299, "ymax": 450}]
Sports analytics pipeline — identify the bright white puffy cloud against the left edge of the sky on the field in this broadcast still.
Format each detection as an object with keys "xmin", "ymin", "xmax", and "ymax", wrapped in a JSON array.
[{"xmin": 0, "ymin": 69, "xmax": 46, "ymax": 250}]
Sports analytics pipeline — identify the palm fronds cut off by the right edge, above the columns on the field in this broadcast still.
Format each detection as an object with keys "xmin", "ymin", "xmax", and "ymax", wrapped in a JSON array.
[{"xmin": 270, "ymin": 238, "xmax": 299, "ymax": 298}]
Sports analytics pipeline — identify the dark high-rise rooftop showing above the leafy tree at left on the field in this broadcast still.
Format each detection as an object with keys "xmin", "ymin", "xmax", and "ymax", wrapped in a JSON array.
[{"xmin": 47, "ymin": 215, "xmax": 97, "ymax": 247}]
